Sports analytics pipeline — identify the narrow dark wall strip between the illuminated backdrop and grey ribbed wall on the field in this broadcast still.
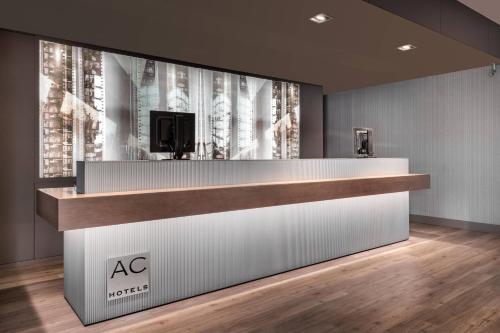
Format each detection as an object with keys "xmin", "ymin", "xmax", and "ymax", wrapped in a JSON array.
[{"xmin": 300, "ymin": 84, "xmax": 323, "ymax": 158}]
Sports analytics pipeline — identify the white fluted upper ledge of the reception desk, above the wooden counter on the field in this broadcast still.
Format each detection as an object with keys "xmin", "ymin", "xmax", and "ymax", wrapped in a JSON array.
[{"xmin": 77, "ymin": 158, "xmax": 408, "ymax": 193}]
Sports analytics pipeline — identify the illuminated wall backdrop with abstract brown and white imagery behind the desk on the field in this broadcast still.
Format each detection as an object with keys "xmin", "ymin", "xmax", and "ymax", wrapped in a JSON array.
[{"xmin": 39, "ymin": 41, "xmax": 300, "ymax": 178}]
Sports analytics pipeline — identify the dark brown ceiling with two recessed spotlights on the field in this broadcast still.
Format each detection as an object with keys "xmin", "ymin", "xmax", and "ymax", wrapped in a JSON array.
[{"xmin": 0, "ymin": 0, "xmax": 496, "ymax": 93}]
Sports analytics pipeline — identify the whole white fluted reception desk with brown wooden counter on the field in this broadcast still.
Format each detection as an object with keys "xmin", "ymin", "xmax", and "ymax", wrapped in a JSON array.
[{"xmin": 37, "ymin": 158, "xmax": 430, "ymax": 324}]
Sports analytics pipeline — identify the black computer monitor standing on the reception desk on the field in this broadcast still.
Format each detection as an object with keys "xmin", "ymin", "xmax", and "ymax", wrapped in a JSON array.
[{"xmin": 150, "ymin": 111, "xmax": 195, "ymax": 159}]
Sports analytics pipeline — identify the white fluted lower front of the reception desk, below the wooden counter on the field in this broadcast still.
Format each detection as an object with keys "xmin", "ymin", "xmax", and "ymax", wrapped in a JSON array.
[{"xmin": 64, "ymin": 192, "xmax": 409, "ymax": 324}]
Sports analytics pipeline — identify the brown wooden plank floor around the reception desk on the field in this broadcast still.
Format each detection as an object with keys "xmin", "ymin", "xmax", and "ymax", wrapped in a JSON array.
[{"xmin": 0, "ymin": 224, "xmax": 500, "ymax": 333}]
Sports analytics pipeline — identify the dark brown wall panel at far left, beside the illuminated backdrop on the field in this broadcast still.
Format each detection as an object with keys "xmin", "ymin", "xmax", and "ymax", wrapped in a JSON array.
[{"xmin": 0, "ymin": 30, "xmax": 35, "ymax": 264}]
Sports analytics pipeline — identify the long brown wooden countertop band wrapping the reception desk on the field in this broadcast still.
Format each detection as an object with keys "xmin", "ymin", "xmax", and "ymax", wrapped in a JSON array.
[{"xmin": 36, "ymin": 174, "xmax": 430, "ymax": 231}]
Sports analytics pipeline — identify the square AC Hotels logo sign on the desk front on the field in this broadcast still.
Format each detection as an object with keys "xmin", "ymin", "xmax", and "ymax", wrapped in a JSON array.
[{"xmin": 107, "ymin": 252, "xmax": 149, "ymax": 301}]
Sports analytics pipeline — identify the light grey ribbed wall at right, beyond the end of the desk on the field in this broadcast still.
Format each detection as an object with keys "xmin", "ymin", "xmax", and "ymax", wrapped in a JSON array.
[{"xmin": 325, "ymin": 67, "xmax": 500, "ymax": 224}]
